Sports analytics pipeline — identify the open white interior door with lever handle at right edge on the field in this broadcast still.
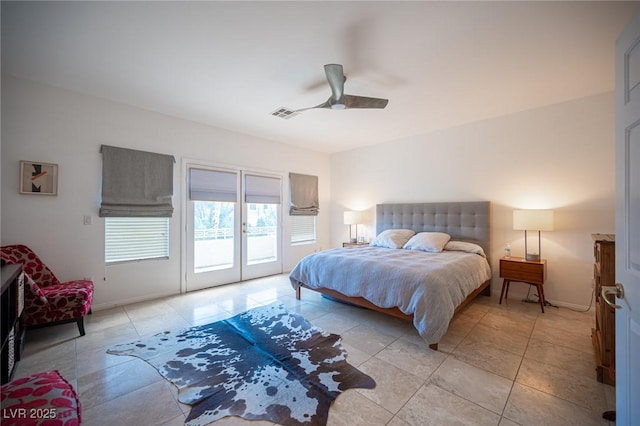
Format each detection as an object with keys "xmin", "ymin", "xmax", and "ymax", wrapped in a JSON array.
[{"xmin": 616, "ymin": 13, "xmax": 640, "ymax": 425}]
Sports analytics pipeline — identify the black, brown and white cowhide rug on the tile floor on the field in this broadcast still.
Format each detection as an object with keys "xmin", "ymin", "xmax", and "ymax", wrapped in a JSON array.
[{"xmin": 107, "ymin": 305, "xmax": 375, "ymax": 426}]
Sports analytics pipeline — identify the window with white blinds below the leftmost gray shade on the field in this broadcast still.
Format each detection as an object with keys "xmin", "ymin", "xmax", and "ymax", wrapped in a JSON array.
[{"xmin": 104, "ymin": 217, "xmax": 169, "ymax": 263}]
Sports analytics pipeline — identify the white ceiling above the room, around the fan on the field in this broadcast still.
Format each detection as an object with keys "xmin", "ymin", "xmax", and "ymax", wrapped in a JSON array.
[{"xmin": 2, "ymin": 1, "xmax": 640, "ymax": 153}]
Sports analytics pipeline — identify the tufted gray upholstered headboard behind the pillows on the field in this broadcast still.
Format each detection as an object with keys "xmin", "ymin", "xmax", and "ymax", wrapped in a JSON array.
[{"xmin": 376, "ymin": 201, "xmax": 491, "ymax": 256}]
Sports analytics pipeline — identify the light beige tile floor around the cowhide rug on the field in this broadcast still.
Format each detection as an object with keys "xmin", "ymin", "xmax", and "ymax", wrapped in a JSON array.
[{"xmin": 15, "ymin": 275, "xmax": 615, "ymax": 426}]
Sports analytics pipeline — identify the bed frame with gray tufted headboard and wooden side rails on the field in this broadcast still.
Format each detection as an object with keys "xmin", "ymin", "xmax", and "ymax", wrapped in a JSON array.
[{"xmin": 296, "ymin": 201, "xmax": 491, "ymax": 350}]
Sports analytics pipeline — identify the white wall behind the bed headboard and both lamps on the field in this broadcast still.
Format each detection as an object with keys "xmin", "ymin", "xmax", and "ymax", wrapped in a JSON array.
[{"xmin": 331, "ymin": 93, "xmax": 615, "ymax": 307}]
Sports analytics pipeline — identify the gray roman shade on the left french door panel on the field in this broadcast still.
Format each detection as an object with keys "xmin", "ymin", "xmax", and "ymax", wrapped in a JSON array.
[{"xmin": 189, "ymin": 168, "xmax": 238, "ymax": 203}]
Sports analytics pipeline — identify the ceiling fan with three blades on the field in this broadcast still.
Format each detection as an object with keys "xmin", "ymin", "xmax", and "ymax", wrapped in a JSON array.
[{"xmin": 272, "ymin": 64, "xmax": 389, "ymax": 118}]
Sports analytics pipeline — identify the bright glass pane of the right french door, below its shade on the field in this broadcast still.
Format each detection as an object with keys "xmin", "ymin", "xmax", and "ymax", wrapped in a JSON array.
[{"xmin": 247, "ymin": 203, "xmax": 278, "ymax": 265}]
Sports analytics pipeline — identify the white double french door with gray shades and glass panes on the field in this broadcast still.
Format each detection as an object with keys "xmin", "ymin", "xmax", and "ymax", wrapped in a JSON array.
[{"xmin": 185, "ymin": 164, "xmax": 282, "ymax": 291}]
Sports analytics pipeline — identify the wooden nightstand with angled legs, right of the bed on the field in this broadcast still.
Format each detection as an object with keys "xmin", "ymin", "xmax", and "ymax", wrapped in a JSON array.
[{"xmin": 500, "ymin": 257, "xmax": 547, "ymax": 313}]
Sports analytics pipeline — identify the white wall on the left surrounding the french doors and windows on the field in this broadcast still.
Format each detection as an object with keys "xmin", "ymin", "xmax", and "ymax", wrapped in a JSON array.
[{"xmin": 1, "ymin": 77, "xmax": 330, "ymax": 309}]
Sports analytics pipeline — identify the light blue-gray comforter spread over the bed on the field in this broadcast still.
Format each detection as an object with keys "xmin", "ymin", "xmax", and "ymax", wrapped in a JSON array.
[{"xmin": 289, "ymin": 246, "xmax": 491, "ymax": 344}]
